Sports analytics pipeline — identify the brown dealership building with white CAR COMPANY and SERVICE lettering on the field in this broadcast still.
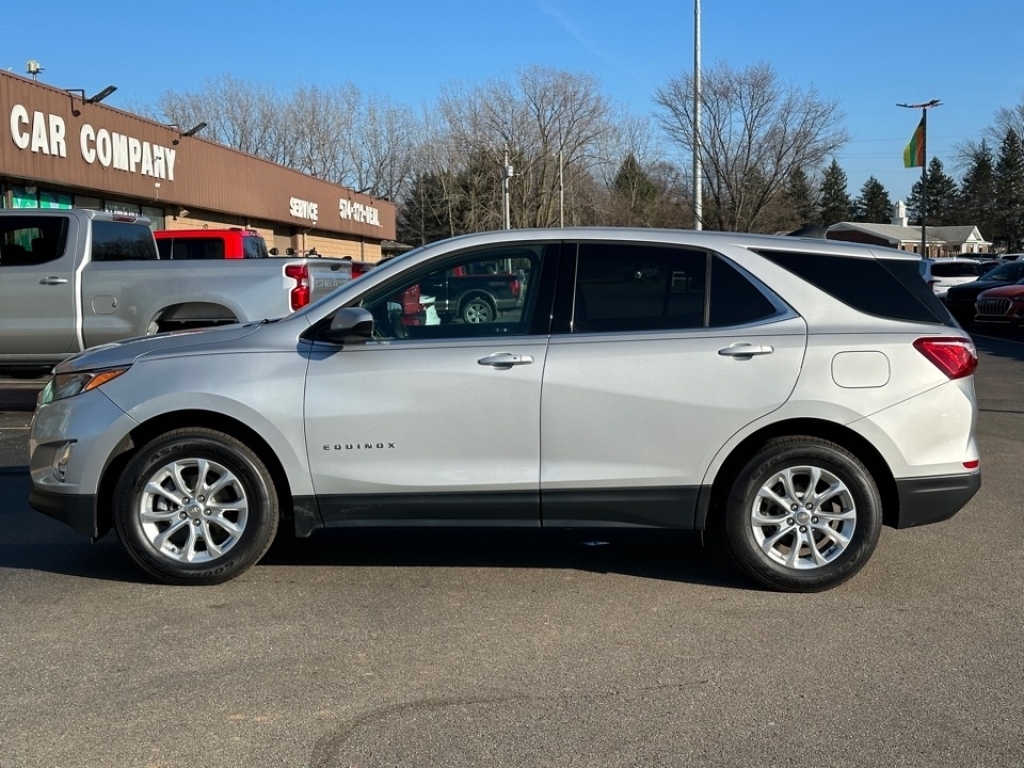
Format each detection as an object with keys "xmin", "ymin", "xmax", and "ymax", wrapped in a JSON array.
[{"xmin": 0, "ymin": 72, "xmax": 396, "ymax": 261}]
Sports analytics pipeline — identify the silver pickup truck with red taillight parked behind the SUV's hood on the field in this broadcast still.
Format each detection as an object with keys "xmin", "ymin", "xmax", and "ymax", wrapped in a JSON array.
[{"xmin": 0, "ymin": 209, "xmax": 351, "ymax": 374}]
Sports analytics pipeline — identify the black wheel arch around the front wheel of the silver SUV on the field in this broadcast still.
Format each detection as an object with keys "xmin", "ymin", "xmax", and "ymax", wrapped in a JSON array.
[{"xmin": 96, "ymin": 410, "xmax": 295, "ymax": 537}]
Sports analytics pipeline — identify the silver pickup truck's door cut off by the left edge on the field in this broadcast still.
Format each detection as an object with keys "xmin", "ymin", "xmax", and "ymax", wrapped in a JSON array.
[{"xmin": 0, "ymin": 212, "xmax": 79, "ymax": 359}]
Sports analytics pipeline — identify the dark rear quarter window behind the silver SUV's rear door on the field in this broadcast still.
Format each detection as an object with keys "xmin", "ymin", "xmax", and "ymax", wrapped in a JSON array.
[{"xmin": 758, "ymin": 251, "xmax": 956, "ymax": 326}]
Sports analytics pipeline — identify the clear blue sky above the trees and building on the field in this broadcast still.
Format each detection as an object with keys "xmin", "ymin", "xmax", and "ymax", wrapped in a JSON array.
[{"xmin": 0, "ymin": 0, "xmax": 1024, "ymax": 207}]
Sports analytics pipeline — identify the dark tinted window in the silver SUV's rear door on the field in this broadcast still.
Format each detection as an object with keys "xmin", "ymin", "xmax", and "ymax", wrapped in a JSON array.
[{"xmin": 572, "ymin": 244, "xmax": 777, "ymax": 333}]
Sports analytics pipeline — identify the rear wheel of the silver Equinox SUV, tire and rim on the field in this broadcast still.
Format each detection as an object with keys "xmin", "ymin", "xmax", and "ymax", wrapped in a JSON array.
[{"xmin": 724, "ymin": 436, "xmax": 882, "ymax": 592}]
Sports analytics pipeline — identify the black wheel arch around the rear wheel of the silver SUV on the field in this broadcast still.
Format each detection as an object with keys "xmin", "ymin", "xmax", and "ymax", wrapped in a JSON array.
[{"xmin": 703, "ymin": 419, "xmax": 899, "ymax": 527}]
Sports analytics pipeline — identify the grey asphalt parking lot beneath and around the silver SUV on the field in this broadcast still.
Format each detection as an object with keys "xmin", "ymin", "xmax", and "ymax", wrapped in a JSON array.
[{"xmin": 0, "ymin": 336, "xmax": 1024, "ymax": 768}]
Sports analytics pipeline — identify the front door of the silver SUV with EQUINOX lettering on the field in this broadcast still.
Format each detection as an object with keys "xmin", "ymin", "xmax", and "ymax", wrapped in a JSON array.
[{"xmin": 304, "ymin": 245, "xmax": 557, "ymax": 526}]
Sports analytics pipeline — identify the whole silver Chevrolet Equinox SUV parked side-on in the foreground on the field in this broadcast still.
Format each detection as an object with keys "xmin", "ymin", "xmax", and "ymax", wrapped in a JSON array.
[{"xmin": 31, "ymin": 228, "xmax": 981, "ymax": 591}]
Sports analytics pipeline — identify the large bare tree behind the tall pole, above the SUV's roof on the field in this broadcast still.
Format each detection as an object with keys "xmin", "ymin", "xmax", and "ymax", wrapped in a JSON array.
[{"xmin": 654, "ymin": 63, "xmax": 849, "ymax": 231}]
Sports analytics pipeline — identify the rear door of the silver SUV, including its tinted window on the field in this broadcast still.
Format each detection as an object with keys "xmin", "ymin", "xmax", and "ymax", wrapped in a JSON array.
[{"xmin": 541, "ymin": 243, "xmax": 807, "ymax": 527}]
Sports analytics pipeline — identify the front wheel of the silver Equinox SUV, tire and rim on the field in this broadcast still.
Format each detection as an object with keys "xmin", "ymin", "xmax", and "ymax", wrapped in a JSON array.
[{"xmin": 114, "ymin": 427, "xmax": 280, "ymax": 585}]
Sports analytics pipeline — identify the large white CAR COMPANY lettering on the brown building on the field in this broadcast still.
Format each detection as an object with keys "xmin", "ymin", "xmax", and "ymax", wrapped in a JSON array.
[{"xmin": 9, "ymin": 104, "xmax": 177, "ymax": 181}]
